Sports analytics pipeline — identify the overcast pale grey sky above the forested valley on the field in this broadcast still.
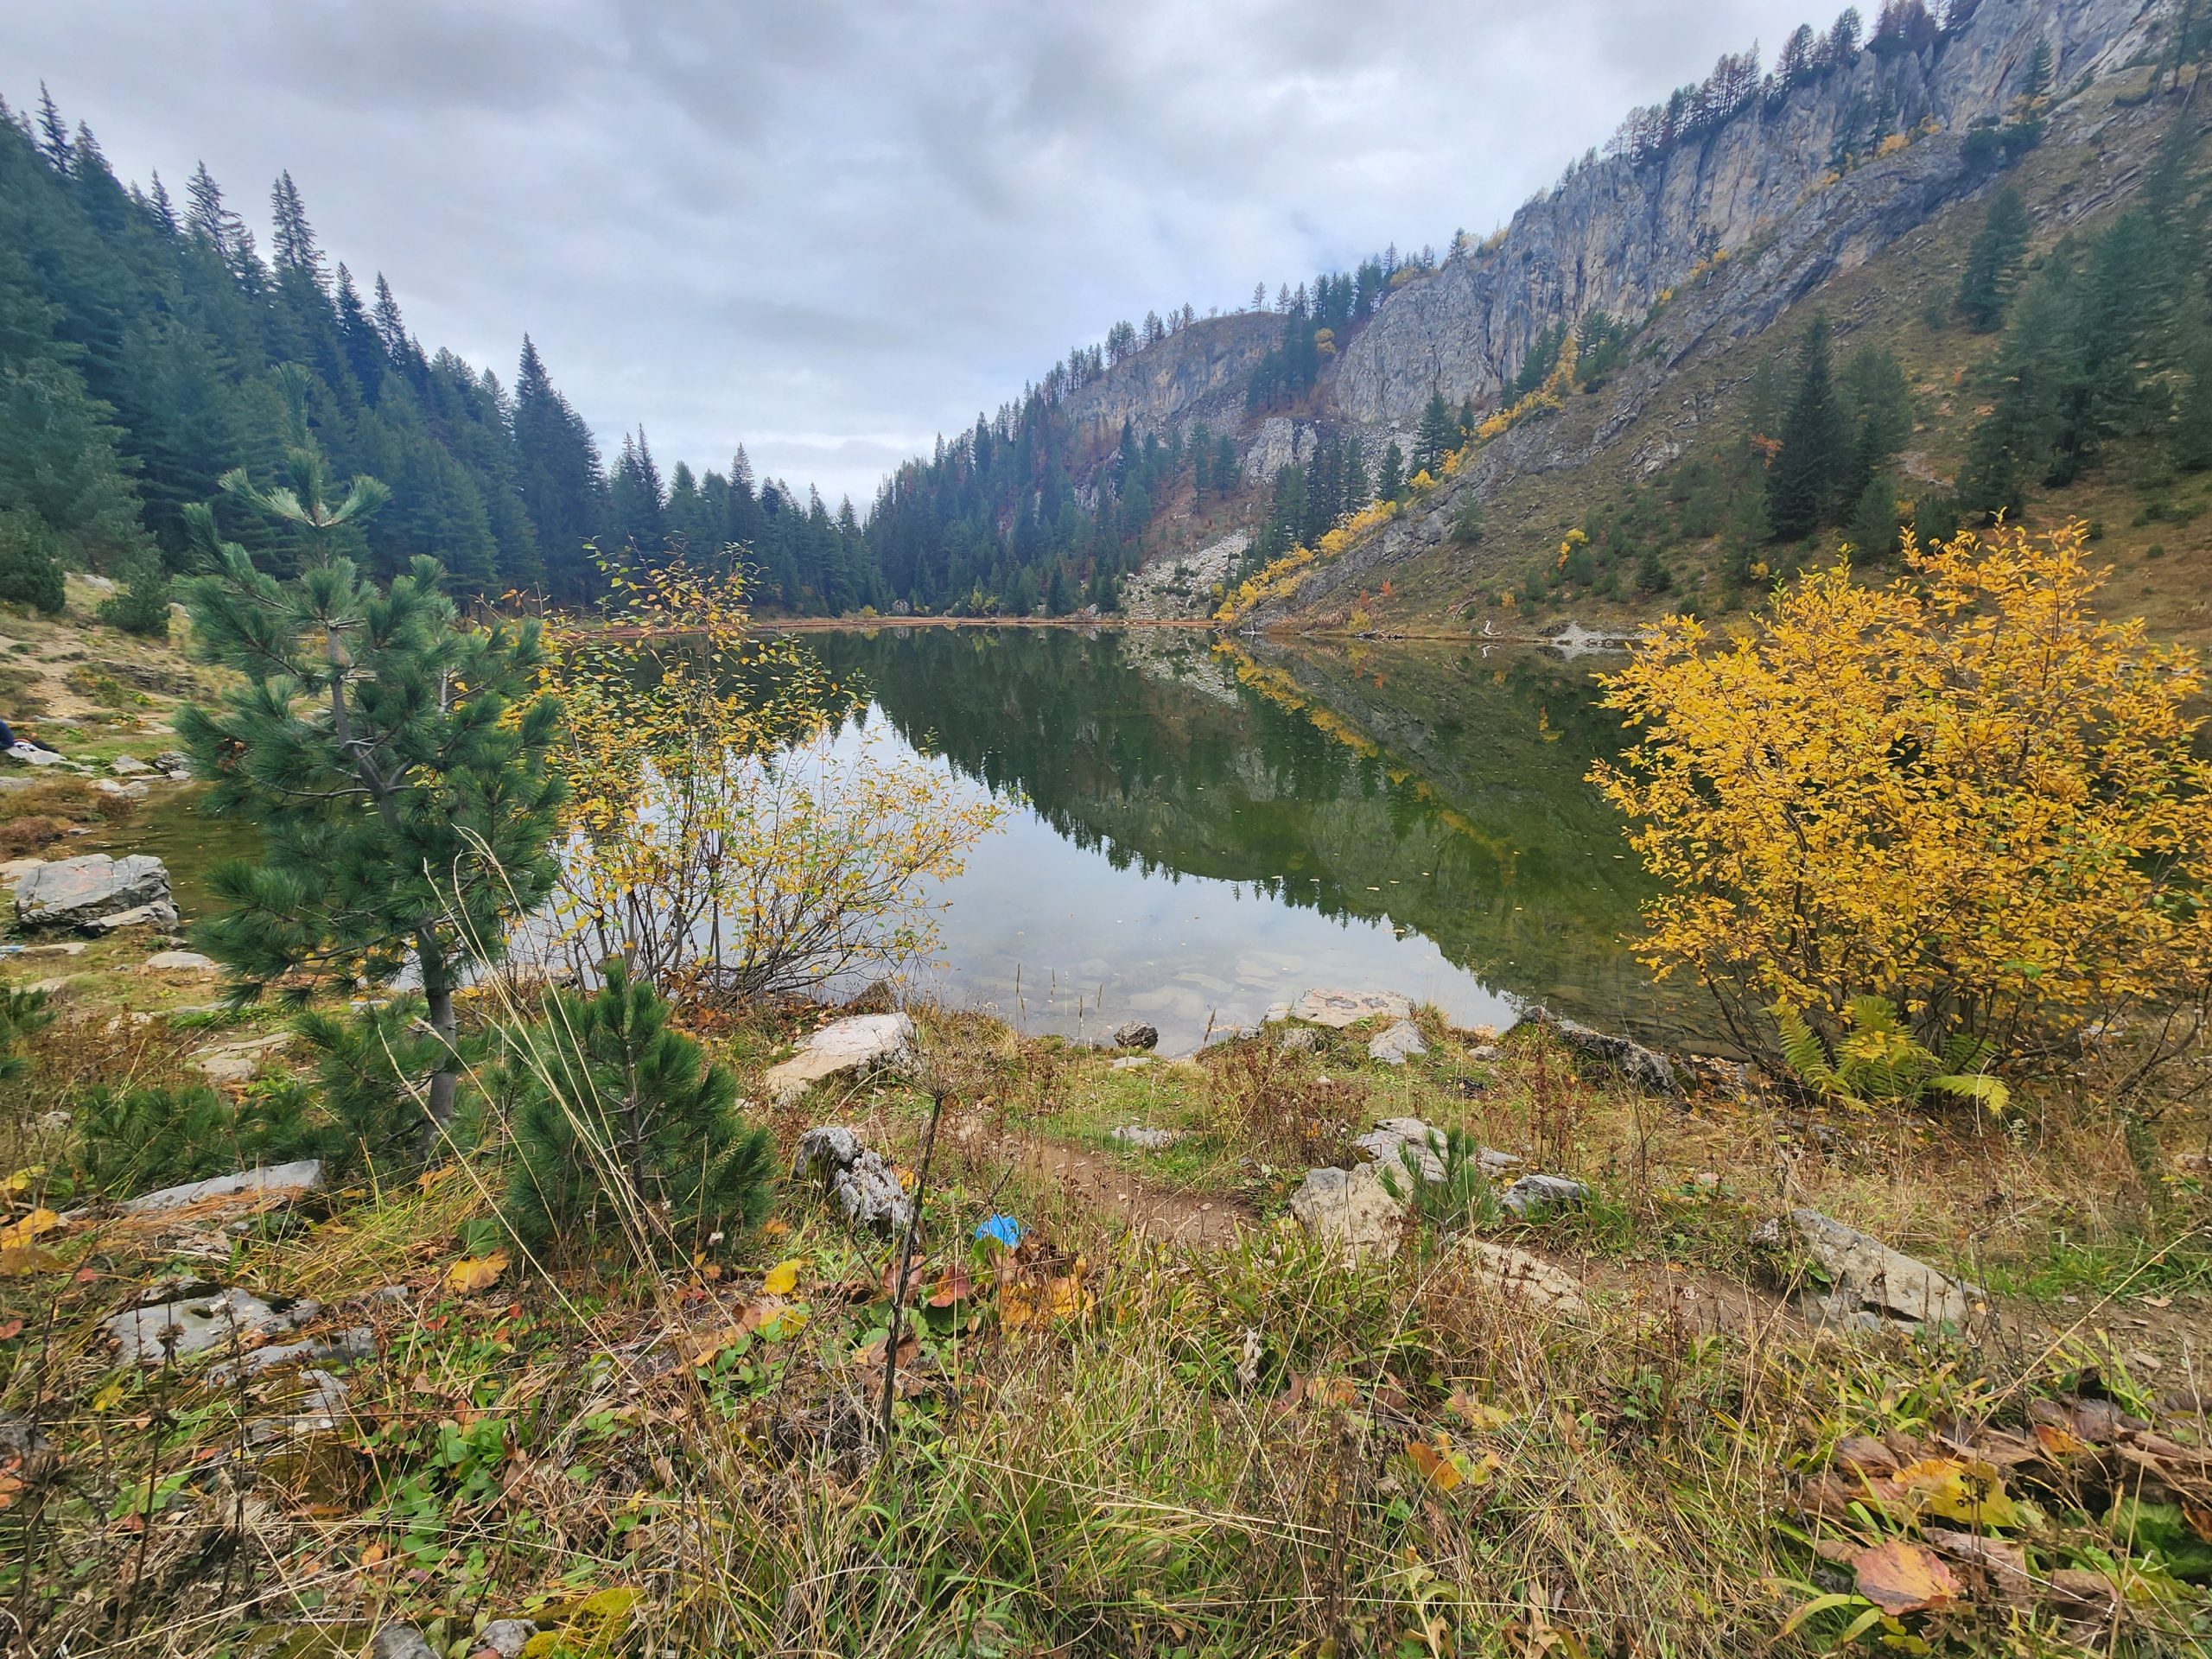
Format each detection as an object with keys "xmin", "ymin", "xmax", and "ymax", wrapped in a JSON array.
[{"xmin": 0, "ymin": 0, "xmax": 1834, "ymax": 511}]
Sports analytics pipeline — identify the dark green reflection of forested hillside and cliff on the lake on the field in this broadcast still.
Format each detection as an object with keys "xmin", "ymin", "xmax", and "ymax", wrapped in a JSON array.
[{"xmin": 810, "ymin": 628, "xmax": 1699, "ymax": 1044}]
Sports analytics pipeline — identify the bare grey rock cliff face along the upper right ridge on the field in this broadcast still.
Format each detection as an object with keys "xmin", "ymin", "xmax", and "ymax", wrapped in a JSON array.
[{"xmin": 1334, "ymin": 0, "xmax": 2170, "ymax": 429}]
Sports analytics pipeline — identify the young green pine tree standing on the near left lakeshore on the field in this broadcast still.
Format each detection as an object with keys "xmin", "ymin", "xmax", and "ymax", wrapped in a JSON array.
[{"xmin": 177, "ymin": 389, "xmax": 560, "ymax": 1126}]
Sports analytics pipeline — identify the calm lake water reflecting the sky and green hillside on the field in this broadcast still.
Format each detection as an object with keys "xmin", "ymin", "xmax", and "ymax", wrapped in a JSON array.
[{"xmin": 805, "ymin": 628, "xmax": 1699, "ymax": 1053}]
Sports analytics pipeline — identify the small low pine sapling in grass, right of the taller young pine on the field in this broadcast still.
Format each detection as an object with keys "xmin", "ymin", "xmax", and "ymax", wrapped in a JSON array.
[{"xmin": 505, "ymin": 963, "xmax": 777, "ymax": 1259}]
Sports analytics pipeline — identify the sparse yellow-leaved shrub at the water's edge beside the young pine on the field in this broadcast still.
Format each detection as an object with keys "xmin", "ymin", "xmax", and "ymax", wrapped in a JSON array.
[{"xmin": 546, "ymin": 560, "xmax": 998, "ymax": 998}]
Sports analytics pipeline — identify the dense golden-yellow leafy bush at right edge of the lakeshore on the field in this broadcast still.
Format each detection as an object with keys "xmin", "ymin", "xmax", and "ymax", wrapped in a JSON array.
[{"xmin": 1592, "ymin": 524, "xmax": 2212, "ymax": 1084}]
